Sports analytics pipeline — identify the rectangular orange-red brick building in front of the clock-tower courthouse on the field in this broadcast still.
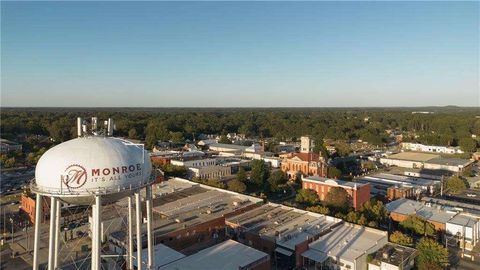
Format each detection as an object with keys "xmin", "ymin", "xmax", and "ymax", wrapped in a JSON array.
[{"xmin": 302, "ymin": 176, "xmax": 370, "ymax": 210}]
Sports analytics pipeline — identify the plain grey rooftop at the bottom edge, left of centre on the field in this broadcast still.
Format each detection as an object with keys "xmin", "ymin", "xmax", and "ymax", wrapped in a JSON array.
[{"xmin": 159, "ymin": 240, "xmax": 269, "ymax": 270}]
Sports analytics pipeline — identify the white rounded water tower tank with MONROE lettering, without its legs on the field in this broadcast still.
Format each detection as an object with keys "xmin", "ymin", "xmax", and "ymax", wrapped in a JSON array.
[{"xmin": 32, "ymin": 136, "xmax": 154, "ymax": 204}]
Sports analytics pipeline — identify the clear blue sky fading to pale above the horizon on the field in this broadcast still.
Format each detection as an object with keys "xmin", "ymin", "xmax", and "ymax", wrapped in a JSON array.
[{"xmin": 1, "ymin": 1, "xmax": 480, "ymax": 107}]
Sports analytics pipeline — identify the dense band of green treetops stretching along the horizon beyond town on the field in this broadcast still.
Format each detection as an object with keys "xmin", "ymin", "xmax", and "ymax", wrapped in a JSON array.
[{"xmin": 1, "ymin": 108, "xmax": 480, "ymax": 151}]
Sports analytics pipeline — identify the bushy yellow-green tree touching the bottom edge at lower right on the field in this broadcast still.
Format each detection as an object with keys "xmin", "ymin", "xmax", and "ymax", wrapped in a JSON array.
[{"xmin": 416, "ymin": 237, "xmax": 449, "ymax": 270}]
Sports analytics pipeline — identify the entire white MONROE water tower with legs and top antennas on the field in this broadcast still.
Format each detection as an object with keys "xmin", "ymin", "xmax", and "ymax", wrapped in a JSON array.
[{"xmin": 31, "ymin": 117, "xmax": 154, "ymax": 270}]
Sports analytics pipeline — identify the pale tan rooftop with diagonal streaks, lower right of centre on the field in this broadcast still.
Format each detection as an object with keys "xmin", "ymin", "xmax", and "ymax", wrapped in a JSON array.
[{"xmin": 308, "ymin": 223, "xmax": 387, "ymax": 261}]
